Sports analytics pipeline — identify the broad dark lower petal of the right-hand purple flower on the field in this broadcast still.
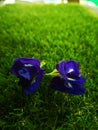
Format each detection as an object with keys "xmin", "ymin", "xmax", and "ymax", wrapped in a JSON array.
[{"xmin": 50, "ymin": 77, "xmax": 85, "ymax": 95}]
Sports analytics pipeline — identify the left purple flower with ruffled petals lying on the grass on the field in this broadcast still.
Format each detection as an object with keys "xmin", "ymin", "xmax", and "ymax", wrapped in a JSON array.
[{"xmin": 11, "ymin": 58, "xmax": 44, "ymax": 94}]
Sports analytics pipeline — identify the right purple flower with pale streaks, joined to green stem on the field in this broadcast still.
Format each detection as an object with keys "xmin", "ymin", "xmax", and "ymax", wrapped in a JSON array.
[{"xmin": 50, "ymin": 61, "xmax": 86, "ymax": 95}]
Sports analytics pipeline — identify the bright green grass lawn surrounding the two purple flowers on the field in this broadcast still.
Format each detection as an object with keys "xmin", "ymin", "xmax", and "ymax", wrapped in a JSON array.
[{"xmin": 0, "ymin": 4, "xmax": 98, "ymax": 130}]
